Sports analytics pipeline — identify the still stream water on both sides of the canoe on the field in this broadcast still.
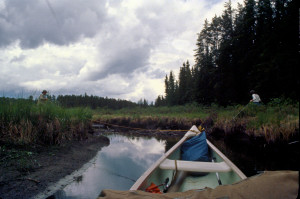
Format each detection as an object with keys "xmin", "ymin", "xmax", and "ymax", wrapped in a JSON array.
[{"xmin": 44, "ymin": 131, "xmax": 299, "ymax": 199}]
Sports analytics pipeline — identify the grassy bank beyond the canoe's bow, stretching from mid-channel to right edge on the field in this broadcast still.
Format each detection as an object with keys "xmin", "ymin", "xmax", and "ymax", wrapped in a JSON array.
[{"xmin": 93, "ymin": 99, "xmax": 299, "ymax": 141}]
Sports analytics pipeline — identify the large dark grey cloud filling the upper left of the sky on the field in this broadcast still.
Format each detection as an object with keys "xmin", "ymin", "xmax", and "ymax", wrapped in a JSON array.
[{"xmin": 0, "ymin": 0, "xmax": 106, "ymax": 48}]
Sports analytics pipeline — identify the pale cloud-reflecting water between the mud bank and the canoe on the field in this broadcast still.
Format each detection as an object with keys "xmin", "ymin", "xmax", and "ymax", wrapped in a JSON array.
[{"xmin": 52, "ymin": 135, "xmax": 166, "ymax": 199}]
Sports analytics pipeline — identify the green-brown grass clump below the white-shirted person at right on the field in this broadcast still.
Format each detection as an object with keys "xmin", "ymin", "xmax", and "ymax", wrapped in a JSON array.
[{"xmin": 211, "ymin": 101, "xmax": 299, "ymax": 142}]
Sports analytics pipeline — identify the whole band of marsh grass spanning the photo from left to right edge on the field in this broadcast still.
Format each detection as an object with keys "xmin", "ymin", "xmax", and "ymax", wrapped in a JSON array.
[{"xmin": 0, "ymin": 98, "xmax": 299, "ymax": 145}]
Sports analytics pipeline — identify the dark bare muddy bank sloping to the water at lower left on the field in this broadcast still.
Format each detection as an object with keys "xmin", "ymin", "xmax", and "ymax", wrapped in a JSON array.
[{"xmin": 0, "ymin": 135, "xmax": 109, "ymax": 199}]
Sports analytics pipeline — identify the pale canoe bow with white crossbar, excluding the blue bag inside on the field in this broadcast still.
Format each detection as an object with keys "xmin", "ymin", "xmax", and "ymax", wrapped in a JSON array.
[{"xmin": 130, "ymin": 126, "xmax": 247, "ymax": 193}]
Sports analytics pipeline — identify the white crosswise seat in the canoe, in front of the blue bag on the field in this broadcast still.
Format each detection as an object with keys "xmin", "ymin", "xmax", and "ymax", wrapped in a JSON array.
[{"xmin": 159, "ymin": 159, "xmax": 231, "ymax": 172}]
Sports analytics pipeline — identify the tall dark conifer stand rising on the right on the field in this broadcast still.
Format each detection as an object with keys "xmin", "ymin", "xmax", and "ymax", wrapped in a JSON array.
[{"xmin": 155, "ymin": 0, "xmax": 299, "ymax": 106}]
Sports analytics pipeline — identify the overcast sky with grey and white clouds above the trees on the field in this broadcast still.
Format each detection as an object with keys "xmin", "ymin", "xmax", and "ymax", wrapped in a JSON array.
[{"xmin": 0, "ymin": 0, "xmax": 243, "ymax": 102}]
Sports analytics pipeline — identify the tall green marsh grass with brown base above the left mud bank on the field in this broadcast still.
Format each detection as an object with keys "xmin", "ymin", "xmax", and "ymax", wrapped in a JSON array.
[{"xmin": 0, "ymin": 97, "xmax": 92, "ymax": 145}]
